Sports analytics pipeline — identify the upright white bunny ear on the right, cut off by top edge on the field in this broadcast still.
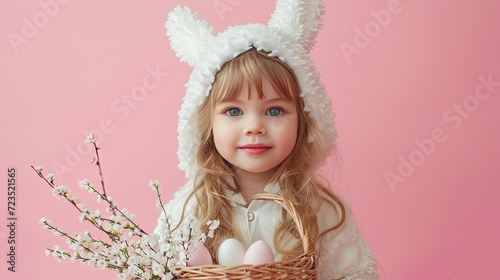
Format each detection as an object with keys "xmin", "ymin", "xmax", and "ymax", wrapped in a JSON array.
[{"xmin": 268, "ymin": 0, "xmax": 325, "ymax": 51}]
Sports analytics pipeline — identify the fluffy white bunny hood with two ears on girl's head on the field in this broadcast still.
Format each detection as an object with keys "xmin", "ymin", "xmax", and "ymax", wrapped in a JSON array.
[{"xmin": 165, "ymin": 0, "xmax": 337, "ymax": 179}]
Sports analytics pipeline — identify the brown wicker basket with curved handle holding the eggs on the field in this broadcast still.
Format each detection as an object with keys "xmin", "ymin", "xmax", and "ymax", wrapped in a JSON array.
[{"xmin": 178, "ymin": 194, "xmax": 317, "ymax": 280}]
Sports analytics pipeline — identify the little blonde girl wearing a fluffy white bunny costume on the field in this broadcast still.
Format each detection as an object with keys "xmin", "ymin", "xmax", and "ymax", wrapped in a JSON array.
[{"xmin": 155, "ymin": 0, "xmax": 379, "ymax": 279}]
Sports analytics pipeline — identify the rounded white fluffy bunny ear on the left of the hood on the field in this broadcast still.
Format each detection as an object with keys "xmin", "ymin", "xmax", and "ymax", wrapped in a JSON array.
[{"xmin": 165, "ymin": 7, "xmax": 215, "ymax": 67}]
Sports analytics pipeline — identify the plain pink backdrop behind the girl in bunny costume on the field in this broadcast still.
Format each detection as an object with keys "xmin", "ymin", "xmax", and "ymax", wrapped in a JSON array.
[{"xmin": 0, "ymin": 0, "xmax": 500, "ymax": 280}]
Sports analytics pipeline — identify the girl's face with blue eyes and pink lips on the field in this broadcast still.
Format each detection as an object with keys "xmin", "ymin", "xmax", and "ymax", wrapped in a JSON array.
[{"xmin": 212, "ymin": 79, "xmax": 298, "ymax": 178}]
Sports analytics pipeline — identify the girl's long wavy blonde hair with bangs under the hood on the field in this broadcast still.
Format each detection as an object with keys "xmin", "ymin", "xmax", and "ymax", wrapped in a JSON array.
[{"xmin": 183, "ymin": 49, "xmax": 346, "ymax": 260}]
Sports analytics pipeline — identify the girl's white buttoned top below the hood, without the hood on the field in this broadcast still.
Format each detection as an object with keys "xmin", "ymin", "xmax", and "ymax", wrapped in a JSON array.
[{"xmin": 154, "ymin": 182, "xmax": 379, "ymax": 280}]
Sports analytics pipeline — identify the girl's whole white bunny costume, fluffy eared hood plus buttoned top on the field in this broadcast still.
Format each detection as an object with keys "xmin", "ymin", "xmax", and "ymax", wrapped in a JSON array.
[{"xmin": 155, "ymin": 0, "xmax": 379, "ymax": 280}]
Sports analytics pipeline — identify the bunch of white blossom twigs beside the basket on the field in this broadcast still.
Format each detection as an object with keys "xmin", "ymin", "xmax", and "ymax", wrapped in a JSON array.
[{"xmin": 31, "ymin": 134, "xmax": 219, "ymax": 280}]
